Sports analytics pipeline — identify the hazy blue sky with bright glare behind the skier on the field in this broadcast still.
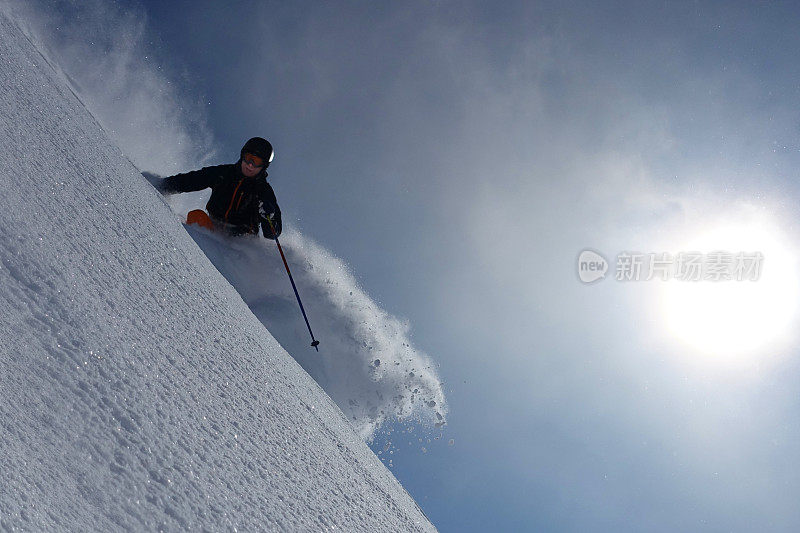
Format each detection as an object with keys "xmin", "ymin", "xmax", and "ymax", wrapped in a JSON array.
[{"xmin": 14, "ymin": 0, "xmax": 800, "ymax": 531}]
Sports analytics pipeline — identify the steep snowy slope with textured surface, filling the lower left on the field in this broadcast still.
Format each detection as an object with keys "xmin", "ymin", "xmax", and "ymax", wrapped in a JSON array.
[{"xmin": 0, "ymin": 10, "xmax": 433, "ymax": 531}]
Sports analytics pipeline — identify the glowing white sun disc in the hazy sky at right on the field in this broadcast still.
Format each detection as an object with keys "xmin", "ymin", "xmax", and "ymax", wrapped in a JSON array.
[{"xmin": 661, "ymin": 221, "xmax": 798, "ymax": 358}]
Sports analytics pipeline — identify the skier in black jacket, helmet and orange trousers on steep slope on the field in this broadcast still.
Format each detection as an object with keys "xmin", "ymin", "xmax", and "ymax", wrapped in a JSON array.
[{"xmin": 158, "ymin": 137, "xmax": 281, "ymax": 240}]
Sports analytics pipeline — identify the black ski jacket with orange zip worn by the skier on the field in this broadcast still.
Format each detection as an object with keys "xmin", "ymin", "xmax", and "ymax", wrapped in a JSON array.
[{"xmin": 161, "ymin": 163, "xmax": 281, "ymax": 239}]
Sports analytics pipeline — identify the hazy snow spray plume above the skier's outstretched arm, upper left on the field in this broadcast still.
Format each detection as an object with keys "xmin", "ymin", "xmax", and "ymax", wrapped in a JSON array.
[{"xmin": 4, "ymin": 0, "xmax": 213, "ymax": 175}]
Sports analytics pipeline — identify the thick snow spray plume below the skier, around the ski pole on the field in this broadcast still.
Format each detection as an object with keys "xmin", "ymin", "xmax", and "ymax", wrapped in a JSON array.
[{"xmin": 189, "ymin": 227, "xmax": 447, "ymax": 441}]
